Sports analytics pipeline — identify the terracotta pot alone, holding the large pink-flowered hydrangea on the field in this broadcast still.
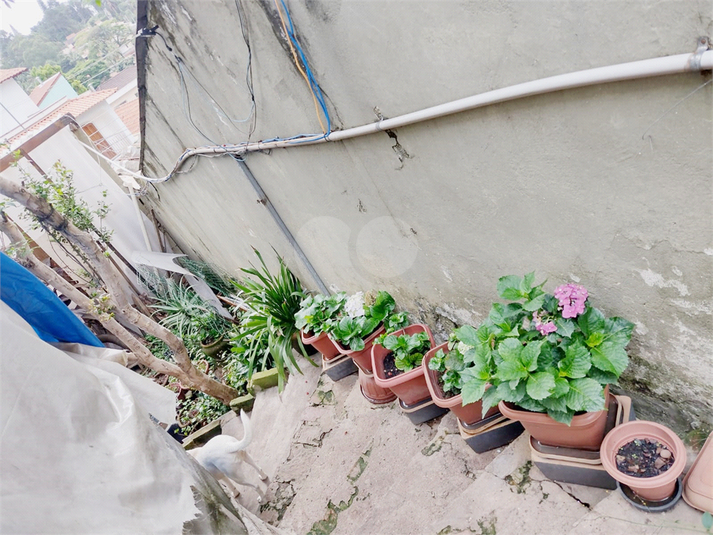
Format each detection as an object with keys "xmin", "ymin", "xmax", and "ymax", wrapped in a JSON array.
[{"xmin": 498, "ymin": 385, "xmax": 609, "ymax": 451}]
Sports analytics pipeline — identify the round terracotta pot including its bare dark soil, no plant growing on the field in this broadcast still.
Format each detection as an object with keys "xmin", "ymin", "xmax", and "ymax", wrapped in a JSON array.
[{"xmin": 600, "ymin": 420, "xmax": 687, "ymax": 507}]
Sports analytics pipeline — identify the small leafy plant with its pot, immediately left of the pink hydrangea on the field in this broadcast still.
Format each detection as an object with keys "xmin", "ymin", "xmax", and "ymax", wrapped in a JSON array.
[{"xmin": 423, "ymin": 325, "xmax": 498, "ymax": 426}]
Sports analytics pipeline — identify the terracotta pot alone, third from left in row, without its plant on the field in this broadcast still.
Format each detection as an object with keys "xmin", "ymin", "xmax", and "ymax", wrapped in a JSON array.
[{"xmin": 371, "ymin": 323, "xmax": 435, "ymax": 405}]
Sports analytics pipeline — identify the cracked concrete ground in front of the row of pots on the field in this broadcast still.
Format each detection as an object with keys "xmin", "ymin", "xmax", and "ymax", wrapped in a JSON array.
[{"xmin": 223, "ymin": 364, "xmax": 705, "ymax": 535}]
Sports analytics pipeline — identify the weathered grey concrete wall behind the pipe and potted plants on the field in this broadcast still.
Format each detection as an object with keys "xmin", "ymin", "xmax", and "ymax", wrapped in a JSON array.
[{"xmin": 143, "ymin": 0, "xmax": 713, "ymax": 434}]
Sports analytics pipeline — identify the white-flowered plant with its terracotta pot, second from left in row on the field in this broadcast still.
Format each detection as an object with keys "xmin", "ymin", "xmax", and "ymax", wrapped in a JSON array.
[{"xmin": 329, "ymin": 290, "xmax": 408, "ymax": 373}]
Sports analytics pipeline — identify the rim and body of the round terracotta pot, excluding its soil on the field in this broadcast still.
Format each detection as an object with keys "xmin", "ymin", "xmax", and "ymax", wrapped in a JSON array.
[{"xmin": 600, "ymin": 420, "xmax": 687, "ymax": 502}]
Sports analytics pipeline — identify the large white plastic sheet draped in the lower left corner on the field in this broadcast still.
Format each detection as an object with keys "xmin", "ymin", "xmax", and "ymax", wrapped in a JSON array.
[{"xmin": 0, "ymin": 302, "xmax": 253, "ymax": 535}]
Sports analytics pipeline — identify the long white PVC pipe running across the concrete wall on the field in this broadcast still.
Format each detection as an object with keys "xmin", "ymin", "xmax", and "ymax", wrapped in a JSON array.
[{"xmin": 101, "ymin": 50, "xmax": 713, "ymax": 182}]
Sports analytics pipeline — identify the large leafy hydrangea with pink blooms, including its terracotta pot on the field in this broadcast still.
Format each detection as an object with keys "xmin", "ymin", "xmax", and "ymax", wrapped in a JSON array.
[{"xmin": 463, "ymin": 273, "xmax": 634, "ymax": 450}]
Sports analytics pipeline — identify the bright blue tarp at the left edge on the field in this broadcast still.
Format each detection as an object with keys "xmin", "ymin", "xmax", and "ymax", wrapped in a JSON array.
[{"xmin": 0, "ymin": 253, "xmax": 104, "ymax": 347}]
